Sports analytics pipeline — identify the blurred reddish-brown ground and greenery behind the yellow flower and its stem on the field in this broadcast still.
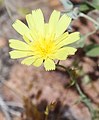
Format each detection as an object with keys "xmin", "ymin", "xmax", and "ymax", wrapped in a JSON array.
[{"xmin": 0, "ymin": 0, "xmax": 99, "ymax": 120}]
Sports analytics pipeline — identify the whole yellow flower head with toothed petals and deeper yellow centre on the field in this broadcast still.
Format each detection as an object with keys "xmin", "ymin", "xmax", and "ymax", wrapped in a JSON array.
[{"xmin": 9, "ymin": 9, "xmax": 80, "ymax": 70}]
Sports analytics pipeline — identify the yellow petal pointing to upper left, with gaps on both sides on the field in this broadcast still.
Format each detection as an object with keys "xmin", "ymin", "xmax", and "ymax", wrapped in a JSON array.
[{"xmin": 12, "ymin": 20, "xmax": 32, "ymax": 40}]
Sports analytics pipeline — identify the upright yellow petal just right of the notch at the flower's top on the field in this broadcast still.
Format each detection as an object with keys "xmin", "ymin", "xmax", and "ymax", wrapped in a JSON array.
[{"xmin": 49, "ymin": 10, "xmax": 60, "ymax": 34}]
